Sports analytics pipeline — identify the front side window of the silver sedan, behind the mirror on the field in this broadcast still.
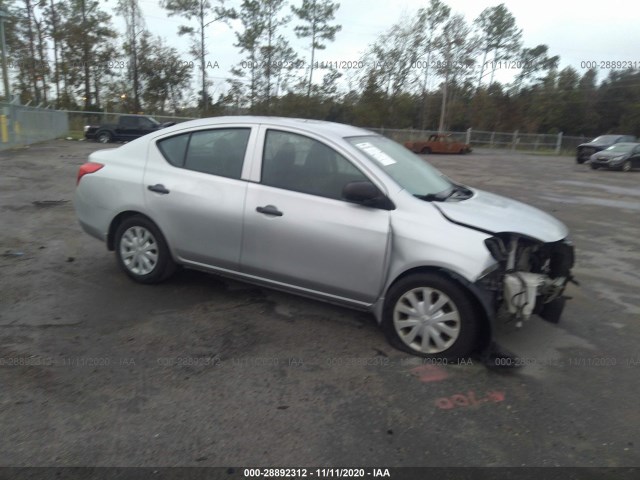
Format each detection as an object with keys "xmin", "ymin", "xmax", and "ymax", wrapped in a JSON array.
[{"xmin": 262, "ymin": 130, "xmax": 368, "ymax": 200}]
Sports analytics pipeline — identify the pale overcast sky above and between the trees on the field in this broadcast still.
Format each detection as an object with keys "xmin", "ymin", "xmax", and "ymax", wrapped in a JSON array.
[{"xmin": 131, "ymin": 0, "xmax": 640, "ymax": 98}]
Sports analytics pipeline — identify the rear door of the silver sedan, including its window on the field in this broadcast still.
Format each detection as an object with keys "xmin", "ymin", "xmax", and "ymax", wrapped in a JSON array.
[{"xmin": 144, "ymin": 125, "xmax": 253, "ymax": 270}]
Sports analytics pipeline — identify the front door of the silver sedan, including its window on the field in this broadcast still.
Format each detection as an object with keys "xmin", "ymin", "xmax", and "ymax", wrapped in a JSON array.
[{"xmin": 241, "ymin": 127, "xmax": 390, "ymax": 302}]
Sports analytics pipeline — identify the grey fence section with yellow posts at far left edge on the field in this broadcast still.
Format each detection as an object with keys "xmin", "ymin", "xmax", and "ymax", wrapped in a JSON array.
[{"xmin": 0, "ymin": 102, "xmax": 69, "ymax": 150}]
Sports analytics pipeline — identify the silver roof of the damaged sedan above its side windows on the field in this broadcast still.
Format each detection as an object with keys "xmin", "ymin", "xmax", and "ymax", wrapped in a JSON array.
[{"xmin": 165, "ymin": 115, "xmax": 377, "ymax": 137}]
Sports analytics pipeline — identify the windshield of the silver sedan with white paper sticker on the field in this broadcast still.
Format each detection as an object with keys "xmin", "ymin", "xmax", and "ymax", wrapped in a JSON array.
[{"xmin": 346, "ymin": 135, "xmax": 453, "ymax": 196}]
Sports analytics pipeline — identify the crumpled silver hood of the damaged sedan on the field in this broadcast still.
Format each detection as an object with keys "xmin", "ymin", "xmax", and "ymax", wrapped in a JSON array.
[{"xmin": 433, "ymin": 190, "xmax": 569, "ymax": 242}]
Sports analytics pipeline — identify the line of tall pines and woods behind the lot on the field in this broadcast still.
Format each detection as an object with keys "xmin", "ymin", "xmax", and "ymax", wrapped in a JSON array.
[{"xmin": 5, "ymin": 0, "xmax": 640, "ymax": 136}]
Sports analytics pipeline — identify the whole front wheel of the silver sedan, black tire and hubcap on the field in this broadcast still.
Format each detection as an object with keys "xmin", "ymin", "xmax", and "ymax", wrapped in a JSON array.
[{"xmin": 382, "ymin": 273, "xmax": 480, "ymax": 360}]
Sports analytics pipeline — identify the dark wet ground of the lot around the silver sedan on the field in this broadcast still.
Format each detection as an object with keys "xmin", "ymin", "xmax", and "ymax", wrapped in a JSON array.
[{"xmin": 0, "ymin": 141, "xmax": 640, "ymax": 467}]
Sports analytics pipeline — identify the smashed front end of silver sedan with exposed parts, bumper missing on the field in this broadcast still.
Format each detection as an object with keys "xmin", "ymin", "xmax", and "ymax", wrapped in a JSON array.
[{"xmin": 477, "ymin": 233, "xmax": 575, "ymax": 327}]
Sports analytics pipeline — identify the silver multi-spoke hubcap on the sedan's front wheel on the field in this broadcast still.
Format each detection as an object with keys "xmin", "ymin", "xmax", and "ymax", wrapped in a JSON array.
[{"xmin": 393, "ymin": 287, "xmax": 460, "ymax": 354}]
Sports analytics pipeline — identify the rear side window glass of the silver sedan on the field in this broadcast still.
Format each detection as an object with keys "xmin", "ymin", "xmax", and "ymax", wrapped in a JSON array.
[{"xmin": 158, "ymin": 128, "xmax": 251, "ymax": 179}]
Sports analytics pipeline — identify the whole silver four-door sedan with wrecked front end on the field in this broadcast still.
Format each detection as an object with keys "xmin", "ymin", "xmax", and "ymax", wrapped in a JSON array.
[{"xmin": 74, "ymin": 116, "xmax": 573, "ymax": 358}]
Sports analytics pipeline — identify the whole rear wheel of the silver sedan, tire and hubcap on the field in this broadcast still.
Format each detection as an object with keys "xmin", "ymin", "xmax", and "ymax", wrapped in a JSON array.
[{"xmin": 115, "ymin": 215, "xmax": 176, "ymax": 284}]
